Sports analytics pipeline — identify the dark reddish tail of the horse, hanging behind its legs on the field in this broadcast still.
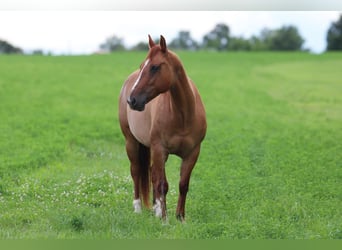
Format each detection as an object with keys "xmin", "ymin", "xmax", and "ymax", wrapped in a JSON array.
[{"xmin": 139, "ymin": 143, "xmax": 151, "ymax": 208}]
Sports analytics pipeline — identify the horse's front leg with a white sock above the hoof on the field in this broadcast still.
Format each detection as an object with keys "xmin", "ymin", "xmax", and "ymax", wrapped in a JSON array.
[{"xmin": 151, "ymin": 147, "xmax": 169, "ymax": 219}]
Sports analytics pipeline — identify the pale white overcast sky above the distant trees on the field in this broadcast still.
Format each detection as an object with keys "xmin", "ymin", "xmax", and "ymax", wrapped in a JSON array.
[{"xmin": 0, "ymin": 10, "xmax": 342, "ymax": 55}]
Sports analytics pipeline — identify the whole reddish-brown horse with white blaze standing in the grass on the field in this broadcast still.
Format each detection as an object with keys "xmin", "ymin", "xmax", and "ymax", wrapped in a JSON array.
[{"xmin": 119, "ymin": 36, "xmax": 207, "ymax": 221}]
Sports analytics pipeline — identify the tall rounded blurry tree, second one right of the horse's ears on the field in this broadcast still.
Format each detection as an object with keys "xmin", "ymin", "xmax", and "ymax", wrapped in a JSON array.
[{"xmin": 203, "ymin": 23, "xmax": 230, "ymax": 51}]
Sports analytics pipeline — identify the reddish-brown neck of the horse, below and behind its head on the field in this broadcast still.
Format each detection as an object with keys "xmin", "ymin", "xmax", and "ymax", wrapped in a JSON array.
[{"xmin": 170, "ymin": 60, "xmax": 195, "ymax": 126}]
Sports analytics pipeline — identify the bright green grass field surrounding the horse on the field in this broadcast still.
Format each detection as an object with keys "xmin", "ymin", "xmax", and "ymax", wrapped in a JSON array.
[{"xmin": 0, "ymin": 52, "xmax": 342, "ymax": 239}]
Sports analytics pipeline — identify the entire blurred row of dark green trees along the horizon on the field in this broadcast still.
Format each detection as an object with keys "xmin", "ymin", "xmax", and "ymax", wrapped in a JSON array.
[{"xmin": 0, "ymin": 15, "xmax": 342, "ymax": 54}]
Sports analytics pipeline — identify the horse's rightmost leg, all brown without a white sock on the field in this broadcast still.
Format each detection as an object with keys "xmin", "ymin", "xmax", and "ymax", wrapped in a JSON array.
[{"xmin": 176, "ymin": 146, "xmax": 200, "ymax": 221}]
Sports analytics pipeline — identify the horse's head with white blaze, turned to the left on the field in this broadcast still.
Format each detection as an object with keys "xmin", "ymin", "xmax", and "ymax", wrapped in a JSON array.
[{"xmin": 127, "ymin": 35, "xmax": 174, "ymax": 111}]
